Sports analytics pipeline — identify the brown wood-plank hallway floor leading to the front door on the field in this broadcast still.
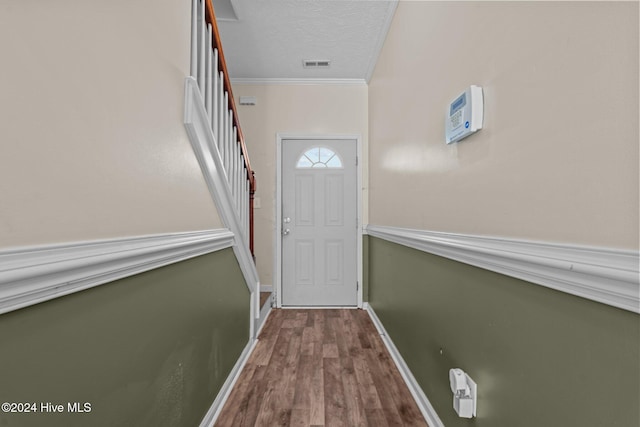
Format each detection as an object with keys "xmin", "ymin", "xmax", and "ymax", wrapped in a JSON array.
[{"xmin": 215, "ymin": 309, "xmax": 427, "ymax": 427}]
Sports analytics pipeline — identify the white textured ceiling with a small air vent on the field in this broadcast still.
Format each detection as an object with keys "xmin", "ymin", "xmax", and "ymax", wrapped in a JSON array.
[{"xmin": 213, "ymin": 0, "xmax": 397, "ymax": 82}]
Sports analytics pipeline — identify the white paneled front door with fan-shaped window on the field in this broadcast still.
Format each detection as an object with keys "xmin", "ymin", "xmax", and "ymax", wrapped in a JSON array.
[{"xmin": 282, "ymin": 140, "xmax": 358, "ymax": 306}]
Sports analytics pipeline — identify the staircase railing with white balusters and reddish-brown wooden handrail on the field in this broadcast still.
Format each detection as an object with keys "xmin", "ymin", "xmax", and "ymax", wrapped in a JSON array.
[{"xmin": 184, "ymin": 0, "xmax": 260, "ymax": 338}]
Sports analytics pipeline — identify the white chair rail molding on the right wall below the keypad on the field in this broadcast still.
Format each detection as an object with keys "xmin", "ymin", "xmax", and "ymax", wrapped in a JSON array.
[{"xmin": 366, "ymin": 225, "xmax": 640, "ymax": 313}]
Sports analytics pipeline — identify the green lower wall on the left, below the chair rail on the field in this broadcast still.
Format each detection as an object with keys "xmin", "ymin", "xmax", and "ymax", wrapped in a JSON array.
[{"xmin": 0, "ymin": 249, "xmax": 250, "ymax": 427}]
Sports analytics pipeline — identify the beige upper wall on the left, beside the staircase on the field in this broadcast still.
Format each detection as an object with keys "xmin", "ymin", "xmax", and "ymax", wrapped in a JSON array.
[{"xmin": 0, "ymin": 0, "xmax": 221, "ymax": 248}]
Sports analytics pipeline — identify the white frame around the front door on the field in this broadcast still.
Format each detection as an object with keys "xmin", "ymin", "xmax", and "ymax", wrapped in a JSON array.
[{"xmin": 273, "ymin": 133, "xmax": 363, "ymax": 308}]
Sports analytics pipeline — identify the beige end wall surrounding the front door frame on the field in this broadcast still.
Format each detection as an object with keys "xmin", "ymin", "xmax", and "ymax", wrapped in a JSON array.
[{"xmin": 233, "ymin": 84, "xmax": 367, "ymax": 285}]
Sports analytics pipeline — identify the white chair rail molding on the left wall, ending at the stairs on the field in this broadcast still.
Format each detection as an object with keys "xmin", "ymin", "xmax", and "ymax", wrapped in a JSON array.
[{"xmin": 0, "ymin": 229, "xmax": 234, "ymax": 314}]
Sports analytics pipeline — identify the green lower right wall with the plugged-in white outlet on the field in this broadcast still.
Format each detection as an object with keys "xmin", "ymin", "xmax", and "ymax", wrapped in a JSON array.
[{"xmin": 368, "ymin": 237, "xmax": 640, "ymax": 427}]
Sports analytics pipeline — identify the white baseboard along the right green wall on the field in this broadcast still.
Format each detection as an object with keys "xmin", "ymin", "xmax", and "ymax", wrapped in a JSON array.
[{"xmin": 363, "ymin": 303, "xmax": 444, "ymax": 427}]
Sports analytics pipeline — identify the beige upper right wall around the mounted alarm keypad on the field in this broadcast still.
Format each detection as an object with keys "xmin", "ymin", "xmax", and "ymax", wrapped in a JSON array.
[{"xmin": 369, "ymin": 2, "xmax": 639, "ymax": 249}]
